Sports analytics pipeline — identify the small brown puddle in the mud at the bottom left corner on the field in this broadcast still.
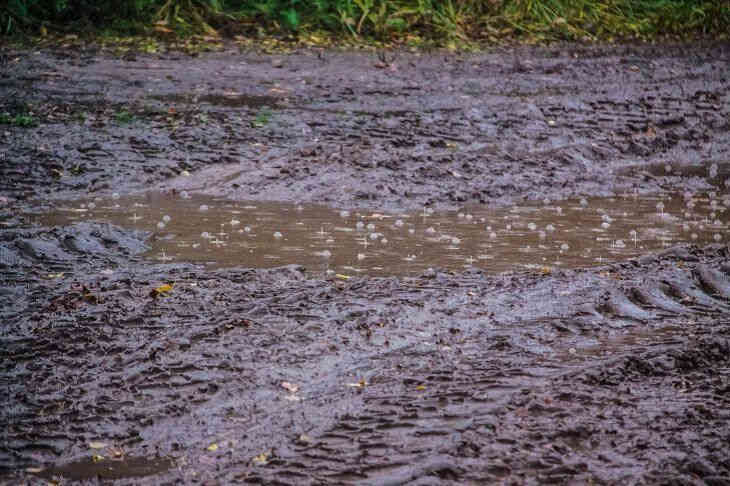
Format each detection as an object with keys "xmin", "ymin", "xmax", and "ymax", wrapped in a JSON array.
[{"xmin": 36, "ymin": 457, "xmax": 175, "ymax": 484}]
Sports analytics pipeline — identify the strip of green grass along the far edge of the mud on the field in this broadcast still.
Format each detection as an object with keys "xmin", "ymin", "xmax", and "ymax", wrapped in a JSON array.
[{"xmin": 0, "ymin": 0, "xmax": 730, "ymax": 45}]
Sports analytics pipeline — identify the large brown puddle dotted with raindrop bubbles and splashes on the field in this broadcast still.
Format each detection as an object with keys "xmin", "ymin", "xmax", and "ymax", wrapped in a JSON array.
[{"xmin": 37, "ymin": 193, "xmax": 730, "ymax": 275}]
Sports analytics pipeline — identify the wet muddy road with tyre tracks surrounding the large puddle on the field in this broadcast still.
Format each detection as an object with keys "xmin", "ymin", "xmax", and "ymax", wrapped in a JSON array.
[{"xmin": 0, "ymin": 44, "xmax": 730, "ymax": 485}]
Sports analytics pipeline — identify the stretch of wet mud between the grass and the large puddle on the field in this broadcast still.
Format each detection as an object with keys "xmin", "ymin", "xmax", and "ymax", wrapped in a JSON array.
[{"xmin": 0, "ymin": 44, "xmax": 730, "ymax": 210}]
